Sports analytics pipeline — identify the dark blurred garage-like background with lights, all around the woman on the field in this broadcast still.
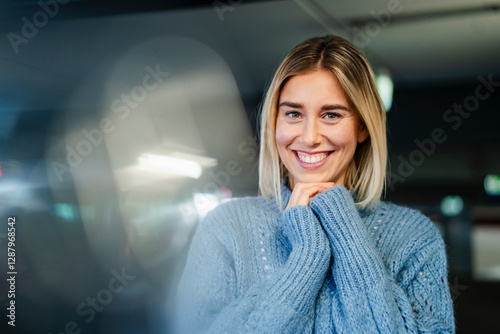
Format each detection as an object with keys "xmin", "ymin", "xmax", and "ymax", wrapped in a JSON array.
[{"xmin": 0, "ymin": 0, "xmax": 500, "ymax": 334}]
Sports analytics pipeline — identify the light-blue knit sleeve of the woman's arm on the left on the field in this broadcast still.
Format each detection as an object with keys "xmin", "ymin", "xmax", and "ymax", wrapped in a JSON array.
[{"xmin": 177, "ymin": 202, "xmax": 331, "ymax": 333}]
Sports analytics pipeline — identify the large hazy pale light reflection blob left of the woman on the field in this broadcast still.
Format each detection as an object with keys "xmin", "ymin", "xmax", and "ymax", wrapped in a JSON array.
[{"xmin": 34, "ymin": 37, "xmax": 256, "ymax": 332}]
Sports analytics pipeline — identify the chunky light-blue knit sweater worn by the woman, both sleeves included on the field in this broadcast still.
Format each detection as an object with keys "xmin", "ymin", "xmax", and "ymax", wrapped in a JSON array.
[{"xmin": 178, "ymin": 185, "xmax": 455, "ymax": 334}]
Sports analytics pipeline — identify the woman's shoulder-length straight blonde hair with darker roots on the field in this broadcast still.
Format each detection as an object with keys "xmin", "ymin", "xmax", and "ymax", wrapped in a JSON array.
[{"xmin": 259, "ymin": 35, "xmax": 387, "ymax": 208}]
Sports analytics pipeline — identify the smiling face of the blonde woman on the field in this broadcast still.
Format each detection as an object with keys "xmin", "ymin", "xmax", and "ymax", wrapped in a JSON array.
[{"xmin": 276, "ymin": 70, "xmax": 368, "ymax": 189}]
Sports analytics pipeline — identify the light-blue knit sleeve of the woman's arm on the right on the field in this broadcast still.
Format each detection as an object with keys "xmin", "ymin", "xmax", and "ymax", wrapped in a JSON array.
[{"xmin": 311, "ymin": 186, "xmax": 455, "ymax": 333}]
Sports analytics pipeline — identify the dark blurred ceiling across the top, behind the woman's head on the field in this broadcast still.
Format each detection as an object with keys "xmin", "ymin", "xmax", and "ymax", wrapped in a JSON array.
[{"xmin": 0, "ymin": 0, "xmax": 500, "ymax": 111}]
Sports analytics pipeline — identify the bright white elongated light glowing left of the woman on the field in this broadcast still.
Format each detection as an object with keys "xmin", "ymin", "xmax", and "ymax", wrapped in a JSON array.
[{"xmin": 139, "ymin": 153, "xmax": 202, "ymax": 179}]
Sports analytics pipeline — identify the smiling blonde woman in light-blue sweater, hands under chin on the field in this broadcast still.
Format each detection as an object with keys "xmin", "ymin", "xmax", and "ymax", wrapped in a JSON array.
[{"xmin": 178, "ymin": 36, "xmax": 455, "ymax": 333}]
